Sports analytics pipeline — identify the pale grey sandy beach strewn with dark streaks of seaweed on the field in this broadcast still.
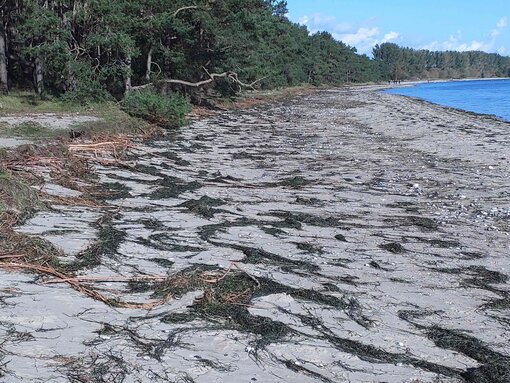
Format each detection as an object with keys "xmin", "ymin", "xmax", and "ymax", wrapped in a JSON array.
[{"xmin": 0, "ymin": 87, "xmax": 510, "ymax": 382}]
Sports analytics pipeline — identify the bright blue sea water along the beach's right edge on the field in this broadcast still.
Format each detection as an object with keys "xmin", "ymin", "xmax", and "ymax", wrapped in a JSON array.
[{"xmin": 385, "ymin": 79, "xmax": 510, "ymax": 121}]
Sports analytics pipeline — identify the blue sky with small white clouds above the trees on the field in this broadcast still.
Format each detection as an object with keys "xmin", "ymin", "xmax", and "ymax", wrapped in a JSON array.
[{"xmin": 287, "ymin": 0, "xmax": 510, "ymax": 56}]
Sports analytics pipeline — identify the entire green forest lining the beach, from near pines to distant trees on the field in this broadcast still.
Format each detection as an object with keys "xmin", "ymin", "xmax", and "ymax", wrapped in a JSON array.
[{"xmin": 0, "ymin": 0, "xmax": 510, "ymax": 103}]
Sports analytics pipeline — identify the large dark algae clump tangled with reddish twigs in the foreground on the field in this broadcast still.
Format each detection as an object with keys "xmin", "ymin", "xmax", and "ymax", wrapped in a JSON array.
[{"xmin": 153, "ymin": 268, "xmax": 468, "ymax": 382}]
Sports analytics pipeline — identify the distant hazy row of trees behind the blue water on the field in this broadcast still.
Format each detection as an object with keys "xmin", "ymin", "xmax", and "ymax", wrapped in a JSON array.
[{"xmin": 373, "ymin": 43, "xmax": 510, "ymax": 80}]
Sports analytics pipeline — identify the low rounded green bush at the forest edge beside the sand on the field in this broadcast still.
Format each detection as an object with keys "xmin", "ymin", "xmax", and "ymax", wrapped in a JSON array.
[{"xmin": 121, "ymin": 89, "xmax": 191, "ymax": 128}]
